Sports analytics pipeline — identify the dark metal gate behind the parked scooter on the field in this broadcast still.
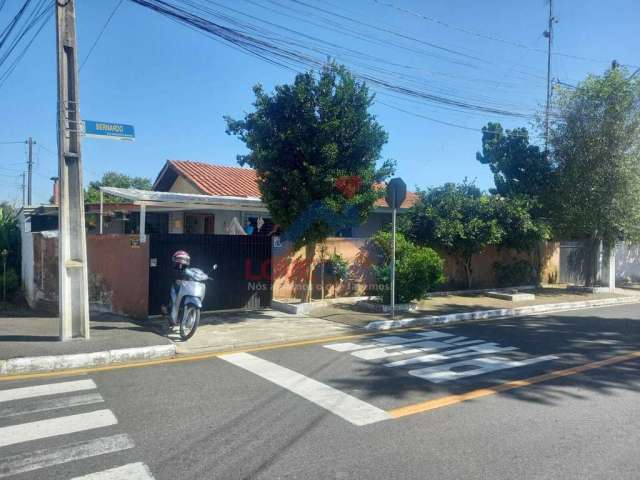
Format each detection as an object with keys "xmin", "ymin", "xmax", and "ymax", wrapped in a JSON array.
[{"xmin": 149, "ymin": 234, "xmax": 272, "ymax": 315}]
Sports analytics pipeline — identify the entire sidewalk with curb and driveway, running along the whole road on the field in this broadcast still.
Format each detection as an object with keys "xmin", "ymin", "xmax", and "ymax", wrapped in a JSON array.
[{"xmin": 0, "ymin": 289, "xmax": 640, "ymax": 377}]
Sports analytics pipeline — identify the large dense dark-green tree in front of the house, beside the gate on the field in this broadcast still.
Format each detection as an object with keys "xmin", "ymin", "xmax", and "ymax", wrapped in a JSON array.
[{"xmin": 225, "ymin": 63, "xmax": 393, "ymax": 299}]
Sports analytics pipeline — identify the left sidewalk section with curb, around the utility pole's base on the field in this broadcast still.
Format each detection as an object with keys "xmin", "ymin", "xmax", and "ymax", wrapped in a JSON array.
[{"xmin": 0, "ymin": 309, "xmax": 175, "ymax": 375}]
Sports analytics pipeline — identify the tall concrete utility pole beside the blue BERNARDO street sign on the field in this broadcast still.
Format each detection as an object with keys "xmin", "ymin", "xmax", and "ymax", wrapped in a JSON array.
[{"xmin": 56, "ymin": 0, "xmax": 89, "ymax": 340}]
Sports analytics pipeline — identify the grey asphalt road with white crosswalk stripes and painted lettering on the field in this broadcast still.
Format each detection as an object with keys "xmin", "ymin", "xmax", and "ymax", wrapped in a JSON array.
[{"xmin": 0, "ymin": 305, "xmax": 640, "ymax": 480}]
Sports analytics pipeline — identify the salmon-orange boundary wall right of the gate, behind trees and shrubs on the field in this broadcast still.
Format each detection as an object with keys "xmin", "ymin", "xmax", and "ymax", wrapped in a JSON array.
[{"xmin": 273, "ymin": 238, "xmax": 560, "ymax": 299}]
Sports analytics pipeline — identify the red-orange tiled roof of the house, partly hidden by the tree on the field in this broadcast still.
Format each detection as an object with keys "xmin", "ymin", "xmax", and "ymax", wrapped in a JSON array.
[{"xmin": 168, "ymin": 160, "xmax": 418, "ymax": 208}]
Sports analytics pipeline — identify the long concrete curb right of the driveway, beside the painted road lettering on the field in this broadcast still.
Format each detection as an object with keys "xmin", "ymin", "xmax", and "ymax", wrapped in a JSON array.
[{"xmin": 364, "ymin": 295, "xmax": 640, "ymax": 332}]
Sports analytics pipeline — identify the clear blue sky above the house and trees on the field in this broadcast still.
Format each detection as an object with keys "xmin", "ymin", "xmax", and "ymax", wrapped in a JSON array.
[{"xmin": 0, "ymin": 0, "xmax": 640, "ymax": 204}]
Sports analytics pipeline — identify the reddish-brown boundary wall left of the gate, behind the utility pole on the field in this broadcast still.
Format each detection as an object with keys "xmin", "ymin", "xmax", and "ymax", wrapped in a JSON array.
[{"xmin": 24, "ymin": 232, "xmax": 149, "ymax": 318}]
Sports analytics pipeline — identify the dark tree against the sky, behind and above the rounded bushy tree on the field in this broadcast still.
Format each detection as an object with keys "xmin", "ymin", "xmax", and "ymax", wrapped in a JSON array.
[{"xmin": 476, "ymin": 122, "xmax": 553, "ymax": 200}]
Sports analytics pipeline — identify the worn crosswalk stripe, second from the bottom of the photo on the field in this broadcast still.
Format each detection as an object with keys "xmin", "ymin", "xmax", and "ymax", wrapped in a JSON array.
[{"xmin": 0, "ymin": 434, "xmax": 134, "ymax": 478}]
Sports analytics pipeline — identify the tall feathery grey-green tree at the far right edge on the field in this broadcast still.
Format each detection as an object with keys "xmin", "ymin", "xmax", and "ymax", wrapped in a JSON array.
[{"xmin": 550, "ymin": 68, "xmax": 640, "ymax": 285}]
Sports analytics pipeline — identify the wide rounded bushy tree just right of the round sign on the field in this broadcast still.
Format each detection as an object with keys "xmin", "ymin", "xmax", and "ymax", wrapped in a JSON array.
[{"xmin": 402, "ymin": 181, "xmax": 504, "ymax": 288}]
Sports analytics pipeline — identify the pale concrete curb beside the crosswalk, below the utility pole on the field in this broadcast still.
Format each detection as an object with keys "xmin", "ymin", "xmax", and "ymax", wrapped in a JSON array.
[{"xmin": 0, "ymin": 344, "xmax": 176, "ymax": 375}]
